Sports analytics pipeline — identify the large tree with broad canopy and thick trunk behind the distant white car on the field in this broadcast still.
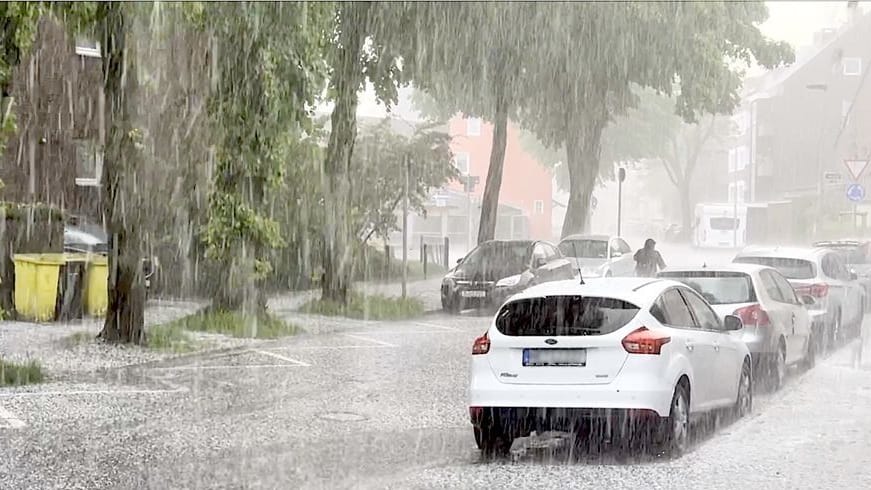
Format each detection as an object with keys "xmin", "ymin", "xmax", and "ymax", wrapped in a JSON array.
[{"xmin": 522, "ymin": 2, "xmax": 792, "ymax": 239}]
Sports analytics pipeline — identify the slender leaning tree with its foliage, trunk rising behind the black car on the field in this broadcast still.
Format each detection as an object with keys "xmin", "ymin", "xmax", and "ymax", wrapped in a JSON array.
[{"xmin": 408, "ymin": 2, "xmax": 546, "ymax": 243}]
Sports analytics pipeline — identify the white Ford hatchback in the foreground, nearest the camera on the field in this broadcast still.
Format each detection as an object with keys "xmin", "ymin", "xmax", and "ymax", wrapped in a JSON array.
[{"xmin": 469, "ymin": 278, "xmax": 753, "ymax": 454}]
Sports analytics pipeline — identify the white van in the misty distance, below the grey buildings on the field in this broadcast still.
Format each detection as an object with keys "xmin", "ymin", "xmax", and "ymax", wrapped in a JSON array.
[{"xmin": 693, "ymin": 203, "xmax": 747, "ymax": 248}]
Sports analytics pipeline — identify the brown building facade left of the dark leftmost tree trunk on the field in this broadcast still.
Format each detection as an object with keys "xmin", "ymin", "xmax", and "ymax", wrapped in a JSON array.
[{"xmin": 0, "ymin": 19, "xmax": 105, "ymax": 218}]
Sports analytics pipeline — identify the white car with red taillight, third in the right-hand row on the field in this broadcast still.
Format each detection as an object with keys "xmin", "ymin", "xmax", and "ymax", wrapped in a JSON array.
[{"xmin": 734, "ymin": 247, "xmax": 865, "ymax": 345}]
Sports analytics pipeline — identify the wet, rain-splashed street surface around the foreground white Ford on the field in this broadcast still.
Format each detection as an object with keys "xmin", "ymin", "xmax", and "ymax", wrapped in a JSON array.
[{"xmin": 0, "ymin": 245, "xmax": 871, "ymax": 489}]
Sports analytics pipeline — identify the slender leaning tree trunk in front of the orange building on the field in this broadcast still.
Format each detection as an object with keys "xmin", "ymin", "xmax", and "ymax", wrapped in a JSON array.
[{"xmin": 478, "ymin": 83, "xmax": 508, "ymax": 244}]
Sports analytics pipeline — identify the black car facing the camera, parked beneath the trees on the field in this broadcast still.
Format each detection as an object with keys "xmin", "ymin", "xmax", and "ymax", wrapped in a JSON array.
[{"xmin": 441, "ymin": 240, "xmax": 577, "ymax": 313}]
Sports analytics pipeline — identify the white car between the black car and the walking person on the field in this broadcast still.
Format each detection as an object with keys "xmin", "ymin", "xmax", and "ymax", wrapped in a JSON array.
[{"xmin": 559, "ymin": 235, "xmax": 635, "ymax": 278}]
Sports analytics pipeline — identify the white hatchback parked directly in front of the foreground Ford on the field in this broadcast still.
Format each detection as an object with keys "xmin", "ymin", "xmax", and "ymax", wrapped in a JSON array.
[{"xmin": 657, "ymin": 264, "xmax": 821, "ymax": 390}]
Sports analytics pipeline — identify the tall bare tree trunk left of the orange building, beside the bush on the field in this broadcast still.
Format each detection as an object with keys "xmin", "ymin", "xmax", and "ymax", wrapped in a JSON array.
[{"xmin": 321, "ymin": 3, "xmax": 370, "ymax": 304}]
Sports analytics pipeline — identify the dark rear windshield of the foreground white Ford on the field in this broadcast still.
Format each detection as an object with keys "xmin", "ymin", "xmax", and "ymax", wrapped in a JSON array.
[{"xmin": 496, "ymin": 296, "xmax": 639, "ymax": 337}]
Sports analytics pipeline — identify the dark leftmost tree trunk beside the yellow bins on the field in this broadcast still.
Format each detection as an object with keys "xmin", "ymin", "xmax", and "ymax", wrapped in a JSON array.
[{"xmin": 100, "ymin": 3, "xmax": 145, "ymax": 344}]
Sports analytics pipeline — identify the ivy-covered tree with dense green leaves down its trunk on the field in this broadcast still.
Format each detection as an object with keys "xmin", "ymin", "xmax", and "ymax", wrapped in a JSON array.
[{"xmin": 204, "ymin": 2, "xmax": 331, "ymax": 311}]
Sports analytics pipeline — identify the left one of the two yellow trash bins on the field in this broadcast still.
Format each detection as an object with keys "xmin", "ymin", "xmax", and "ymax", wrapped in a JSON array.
[{"xmin": 12, "ymin": 253, "xmax": 64, "ymax": 322}]
